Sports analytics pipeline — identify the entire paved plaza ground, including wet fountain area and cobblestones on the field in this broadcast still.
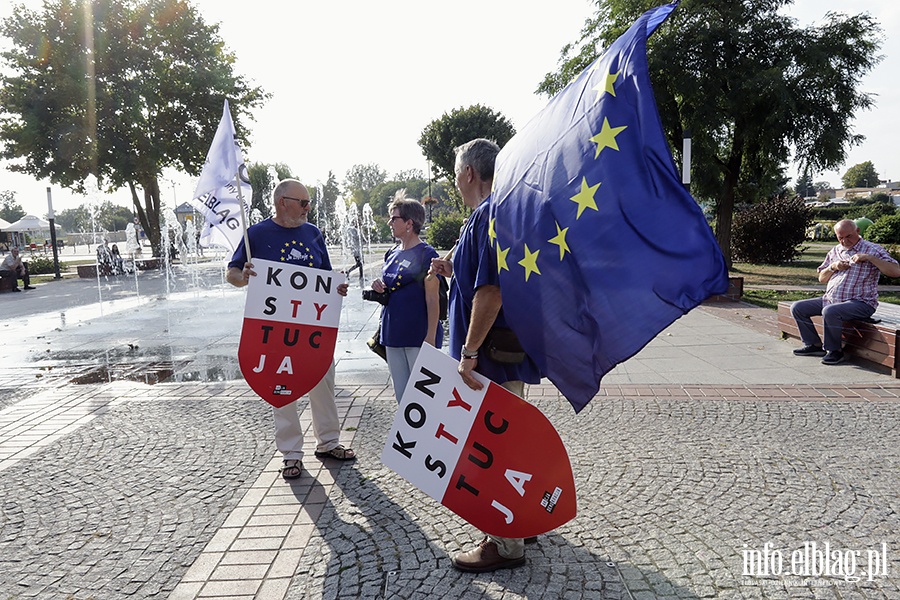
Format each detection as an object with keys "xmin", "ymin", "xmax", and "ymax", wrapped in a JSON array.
[{"xmin": 0, "ymin": 265, "xmax": 900, "ymax": 600}]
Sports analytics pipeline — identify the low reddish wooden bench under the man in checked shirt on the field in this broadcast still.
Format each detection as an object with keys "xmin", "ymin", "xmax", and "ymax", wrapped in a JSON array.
[{"xmin": 778, "ymin": 302, "xmax": 900, "ymax": 378}]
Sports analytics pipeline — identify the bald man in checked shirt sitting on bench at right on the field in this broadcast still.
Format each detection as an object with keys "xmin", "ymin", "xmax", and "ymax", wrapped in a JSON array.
[{"xmin": 791, "ymin": 219, "xmax": 900, "ymax": 365}]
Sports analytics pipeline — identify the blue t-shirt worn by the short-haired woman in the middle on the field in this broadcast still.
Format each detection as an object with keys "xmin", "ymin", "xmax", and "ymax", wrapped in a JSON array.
[{"xmin": 381, "ymin": 243, "xmax": 444, "ymax": 348}]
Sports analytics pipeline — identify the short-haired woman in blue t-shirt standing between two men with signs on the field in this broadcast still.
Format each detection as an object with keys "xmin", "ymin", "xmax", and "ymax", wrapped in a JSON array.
[{"xmin": 372, "ymin": 195, "xmax": 444, "ymax": 402}]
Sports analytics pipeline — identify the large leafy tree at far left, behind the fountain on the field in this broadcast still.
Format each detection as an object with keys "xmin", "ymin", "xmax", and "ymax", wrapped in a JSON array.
[{"xmin": 0, "ymin": 0, "xmax": 266, "ymax": 256}]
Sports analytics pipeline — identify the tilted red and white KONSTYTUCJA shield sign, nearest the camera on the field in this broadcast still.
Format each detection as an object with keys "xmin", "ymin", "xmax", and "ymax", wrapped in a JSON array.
[{"xmin": 381, "ymin": 344, "xmax": 576, "ymax": 538}]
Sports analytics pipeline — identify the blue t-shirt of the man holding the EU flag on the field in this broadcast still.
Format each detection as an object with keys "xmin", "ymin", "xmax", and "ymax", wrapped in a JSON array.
[{"xmin": 449, "ymin": 196, "xmax": 541, "ymax": 383}]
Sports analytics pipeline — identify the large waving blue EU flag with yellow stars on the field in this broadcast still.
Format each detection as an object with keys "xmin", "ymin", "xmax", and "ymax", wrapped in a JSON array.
[{"xmin": 490, "ymin": 2, "xmax": 728, "ymax": 412}]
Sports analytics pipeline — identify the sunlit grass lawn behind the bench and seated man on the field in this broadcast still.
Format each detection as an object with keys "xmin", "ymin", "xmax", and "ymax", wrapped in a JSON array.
[{"xmin": 730, "ymin": 242, "xmax": 900, "ymax": 310}]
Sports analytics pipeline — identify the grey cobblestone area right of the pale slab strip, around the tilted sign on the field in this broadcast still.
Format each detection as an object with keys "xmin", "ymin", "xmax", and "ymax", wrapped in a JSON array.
[{"xmin": 278, "ymin": 385, "xmax": 900, "ymax": 599}]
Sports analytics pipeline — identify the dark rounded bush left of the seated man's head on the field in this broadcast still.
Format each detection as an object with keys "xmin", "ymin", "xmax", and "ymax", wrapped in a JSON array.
[{"xmin": 731, "ymin": 198, "xmax": 812, "ymax": 265}]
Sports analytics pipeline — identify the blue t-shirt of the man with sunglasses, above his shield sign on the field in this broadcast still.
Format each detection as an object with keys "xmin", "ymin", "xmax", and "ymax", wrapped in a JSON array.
[{"xmin": 228, "ymin": 219, "xmax": 331, "ymax": 271}]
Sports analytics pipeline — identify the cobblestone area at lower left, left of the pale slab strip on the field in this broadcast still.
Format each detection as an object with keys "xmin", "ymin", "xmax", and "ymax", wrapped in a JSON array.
[{"xmin": 0, "ymin": 385, "xmax": 272, "ymax": 599}]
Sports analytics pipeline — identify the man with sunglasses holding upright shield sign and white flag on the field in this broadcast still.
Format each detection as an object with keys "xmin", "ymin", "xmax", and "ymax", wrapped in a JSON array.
[{"xmin": 227, "ymin": 179, "xmax": 356, "ymax": 479}]
